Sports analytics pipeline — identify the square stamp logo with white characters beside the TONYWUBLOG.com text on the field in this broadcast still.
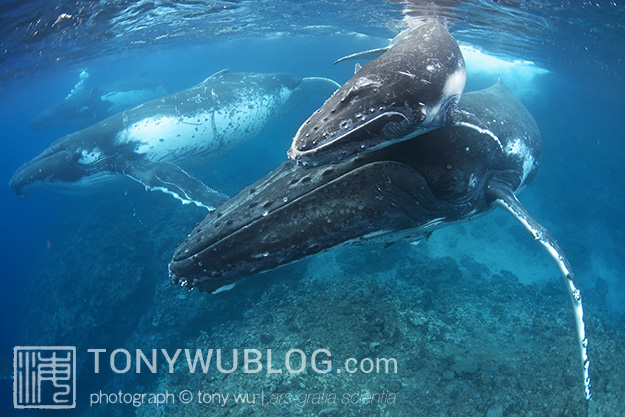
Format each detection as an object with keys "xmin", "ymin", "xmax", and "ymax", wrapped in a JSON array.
[{"xmin": 13, "ymin": 346, "xmax": 76, "ymax": 409}]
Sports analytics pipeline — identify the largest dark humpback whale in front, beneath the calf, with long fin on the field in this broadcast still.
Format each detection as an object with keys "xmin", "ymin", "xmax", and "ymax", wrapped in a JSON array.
[{"xmin": 169, "ymin": 81, "xmax": 590, "ymax": 399}]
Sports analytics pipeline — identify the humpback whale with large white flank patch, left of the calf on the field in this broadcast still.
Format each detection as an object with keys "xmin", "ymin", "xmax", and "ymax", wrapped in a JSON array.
[{"xmin": 9, "ymin": 70, "xmax": 339, "ymax": 210}]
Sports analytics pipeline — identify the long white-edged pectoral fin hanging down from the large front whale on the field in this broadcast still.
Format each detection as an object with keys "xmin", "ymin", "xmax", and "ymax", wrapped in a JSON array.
[{"xmin": 488, "ymin": 184, "xmax": 591, "ymax": 400}]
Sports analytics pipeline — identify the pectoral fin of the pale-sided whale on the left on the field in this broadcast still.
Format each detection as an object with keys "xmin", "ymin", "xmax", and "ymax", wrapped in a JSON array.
[{"xmin": 121, "ymin": 161, "xmax": 228, "ymax": 211}]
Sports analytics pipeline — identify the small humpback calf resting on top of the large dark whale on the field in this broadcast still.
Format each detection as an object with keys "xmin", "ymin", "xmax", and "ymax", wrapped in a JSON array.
[{"xmin": 287, "ymin": 20, "xmax": 483, "ymax": 166}]
